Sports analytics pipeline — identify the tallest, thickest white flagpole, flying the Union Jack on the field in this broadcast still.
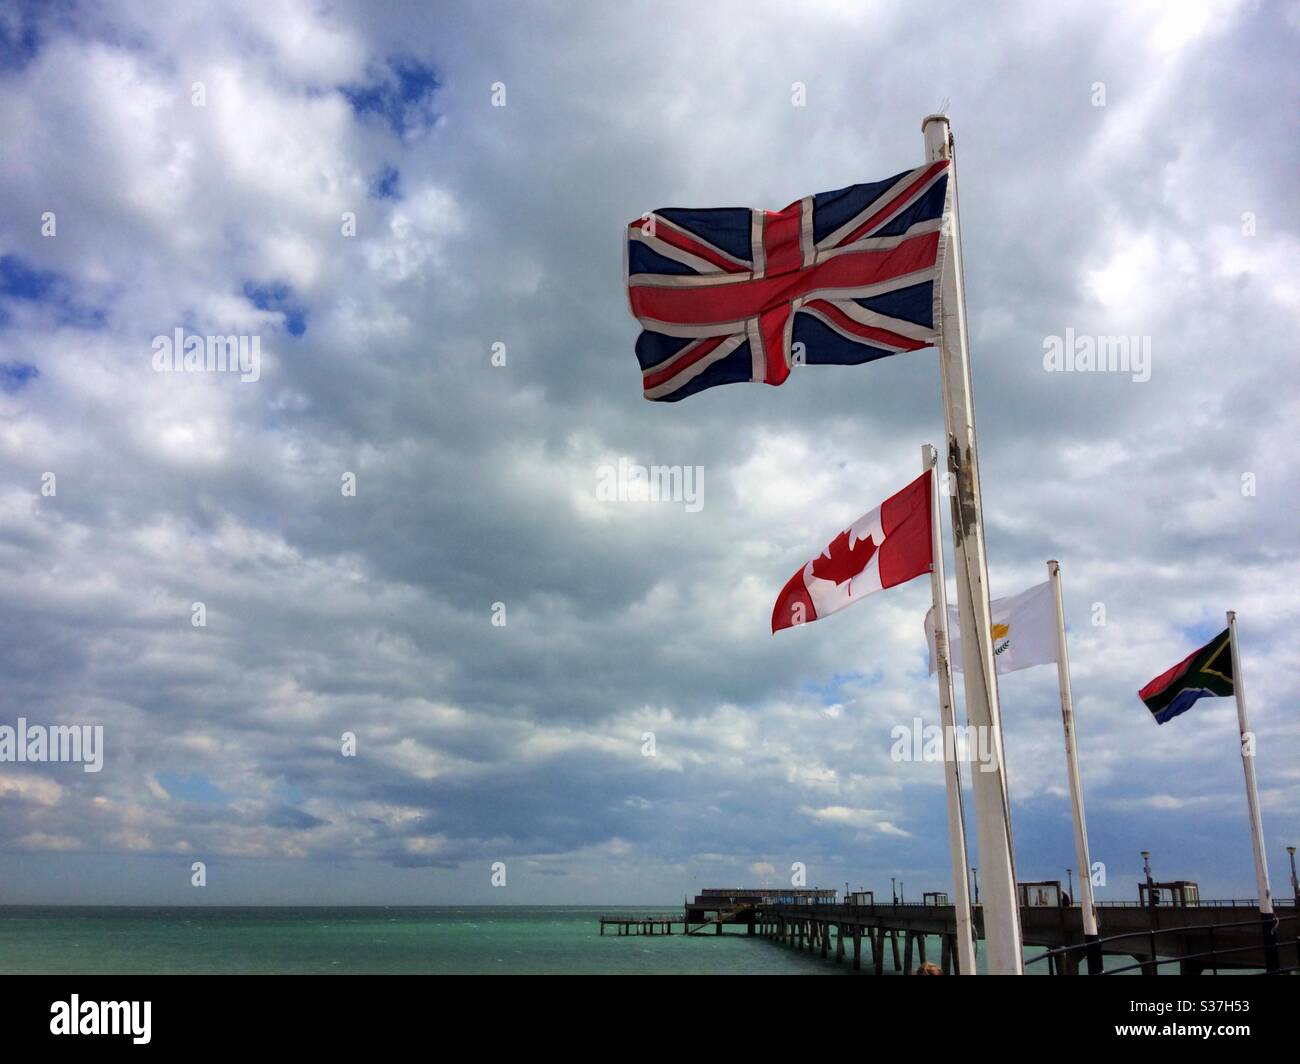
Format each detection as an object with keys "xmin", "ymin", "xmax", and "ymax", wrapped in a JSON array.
[{"xmin": 920, "ymin": 114, "xmax": 1024, "ymax": 976}]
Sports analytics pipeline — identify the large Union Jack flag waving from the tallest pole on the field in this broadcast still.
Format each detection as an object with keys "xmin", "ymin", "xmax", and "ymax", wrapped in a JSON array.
[{"xmin": 627, "ymin": 160, "xmax": 948, "ymax": 402}]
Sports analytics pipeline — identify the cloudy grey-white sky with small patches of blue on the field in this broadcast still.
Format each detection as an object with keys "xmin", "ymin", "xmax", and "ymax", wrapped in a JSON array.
[{"xmin": 0, "ymin": 0, "xmax": 1300, "ymax": 904}]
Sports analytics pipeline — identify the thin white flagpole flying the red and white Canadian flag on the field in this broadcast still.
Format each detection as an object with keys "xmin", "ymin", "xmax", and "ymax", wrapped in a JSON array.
[{"xmin": 920, "ymin": 444, "xmax": 975, "ymax": 976}]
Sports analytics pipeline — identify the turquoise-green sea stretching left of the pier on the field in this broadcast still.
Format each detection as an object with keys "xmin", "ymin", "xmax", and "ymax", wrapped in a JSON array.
[{"xmin": 0, "ymin": 907, "xmax": 883, "ymax": 976}]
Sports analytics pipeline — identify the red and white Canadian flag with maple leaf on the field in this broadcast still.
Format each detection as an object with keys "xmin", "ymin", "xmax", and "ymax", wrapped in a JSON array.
[{"xmin": 772, "ymin": 470, "xmax": 933, "ymax": 632}]
